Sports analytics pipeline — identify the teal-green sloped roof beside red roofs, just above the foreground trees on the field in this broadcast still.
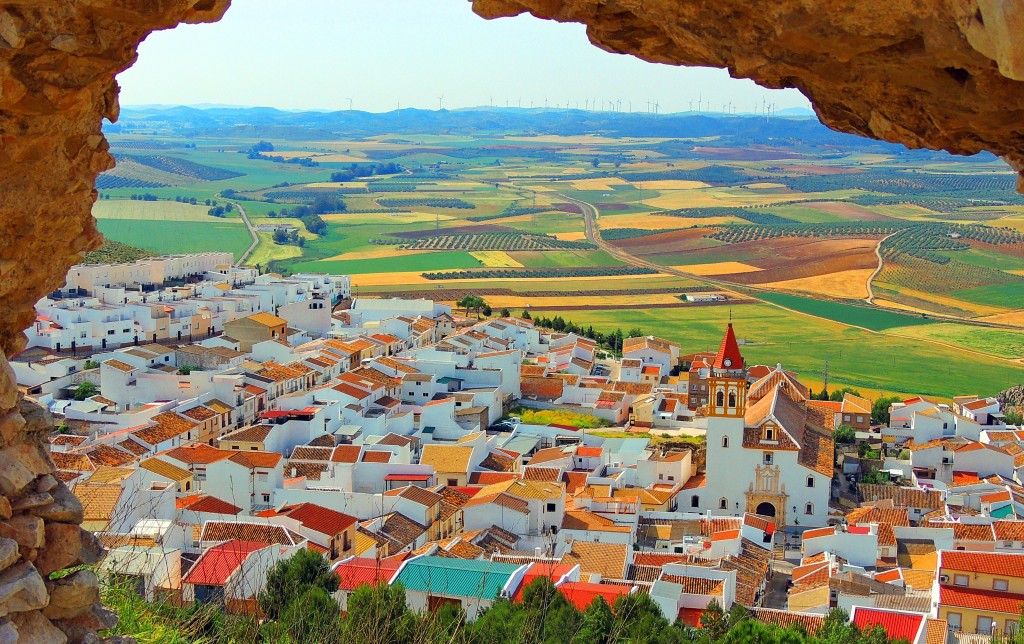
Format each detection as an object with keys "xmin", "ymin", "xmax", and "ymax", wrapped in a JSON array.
[{"xmin": 395, "ymin": 557, "xmax": 520, "ymax": 599}]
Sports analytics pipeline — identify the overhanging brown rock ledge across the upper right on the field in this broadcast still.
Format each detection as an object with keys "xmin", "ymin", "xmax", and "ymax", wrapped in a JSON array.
[{"xmin": 471, "ymin": 0, "xmax": 1024, "ymax": 186}]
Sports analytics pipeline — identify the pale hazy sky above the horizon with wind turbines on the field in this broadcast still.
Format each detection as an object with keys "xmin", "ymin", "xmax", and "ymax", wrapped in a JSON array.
[{"xmin": 119, "ymin": 0, "xmax": 809, "ymax": 114}]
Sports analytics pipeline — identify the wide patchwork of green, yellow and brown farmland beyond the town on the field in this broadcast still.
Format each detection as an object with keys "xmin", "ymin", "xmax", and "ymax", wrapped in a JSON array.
[{"xmin": 95, "ymin": 113, "xmax": 1024, "ymax": 395}]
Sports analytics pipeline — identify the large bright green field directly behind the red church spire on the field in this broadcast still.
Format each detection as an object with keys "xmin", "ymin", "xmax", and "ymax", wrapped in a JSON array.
[{"xmin": 535, "ymin": 304, "xmax": 1024, "ymax": 398}]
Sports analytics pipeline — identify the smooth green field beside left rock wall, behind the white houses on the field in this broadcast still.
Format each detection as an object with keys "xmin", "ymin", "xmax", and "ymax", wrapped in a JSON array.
[{"xmin": 97, "ymin": 216, "xmax": 252, "ymax": 259}]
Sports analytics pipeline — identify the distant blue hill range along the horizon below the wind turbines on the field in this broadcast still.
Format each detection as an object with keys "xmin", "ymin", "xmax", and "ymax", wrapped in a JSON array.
[{"xmin": 104, "ymin": 105, "xmax": 991, "ymax": 159}]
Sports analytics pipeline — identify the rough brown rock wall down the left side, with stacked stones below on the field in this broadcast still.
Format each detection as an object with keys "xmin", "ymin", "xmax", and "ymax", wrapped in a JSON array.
[{"xmin": 0, "ymin": 0, "xmax": 228, "ymax": 643}]
